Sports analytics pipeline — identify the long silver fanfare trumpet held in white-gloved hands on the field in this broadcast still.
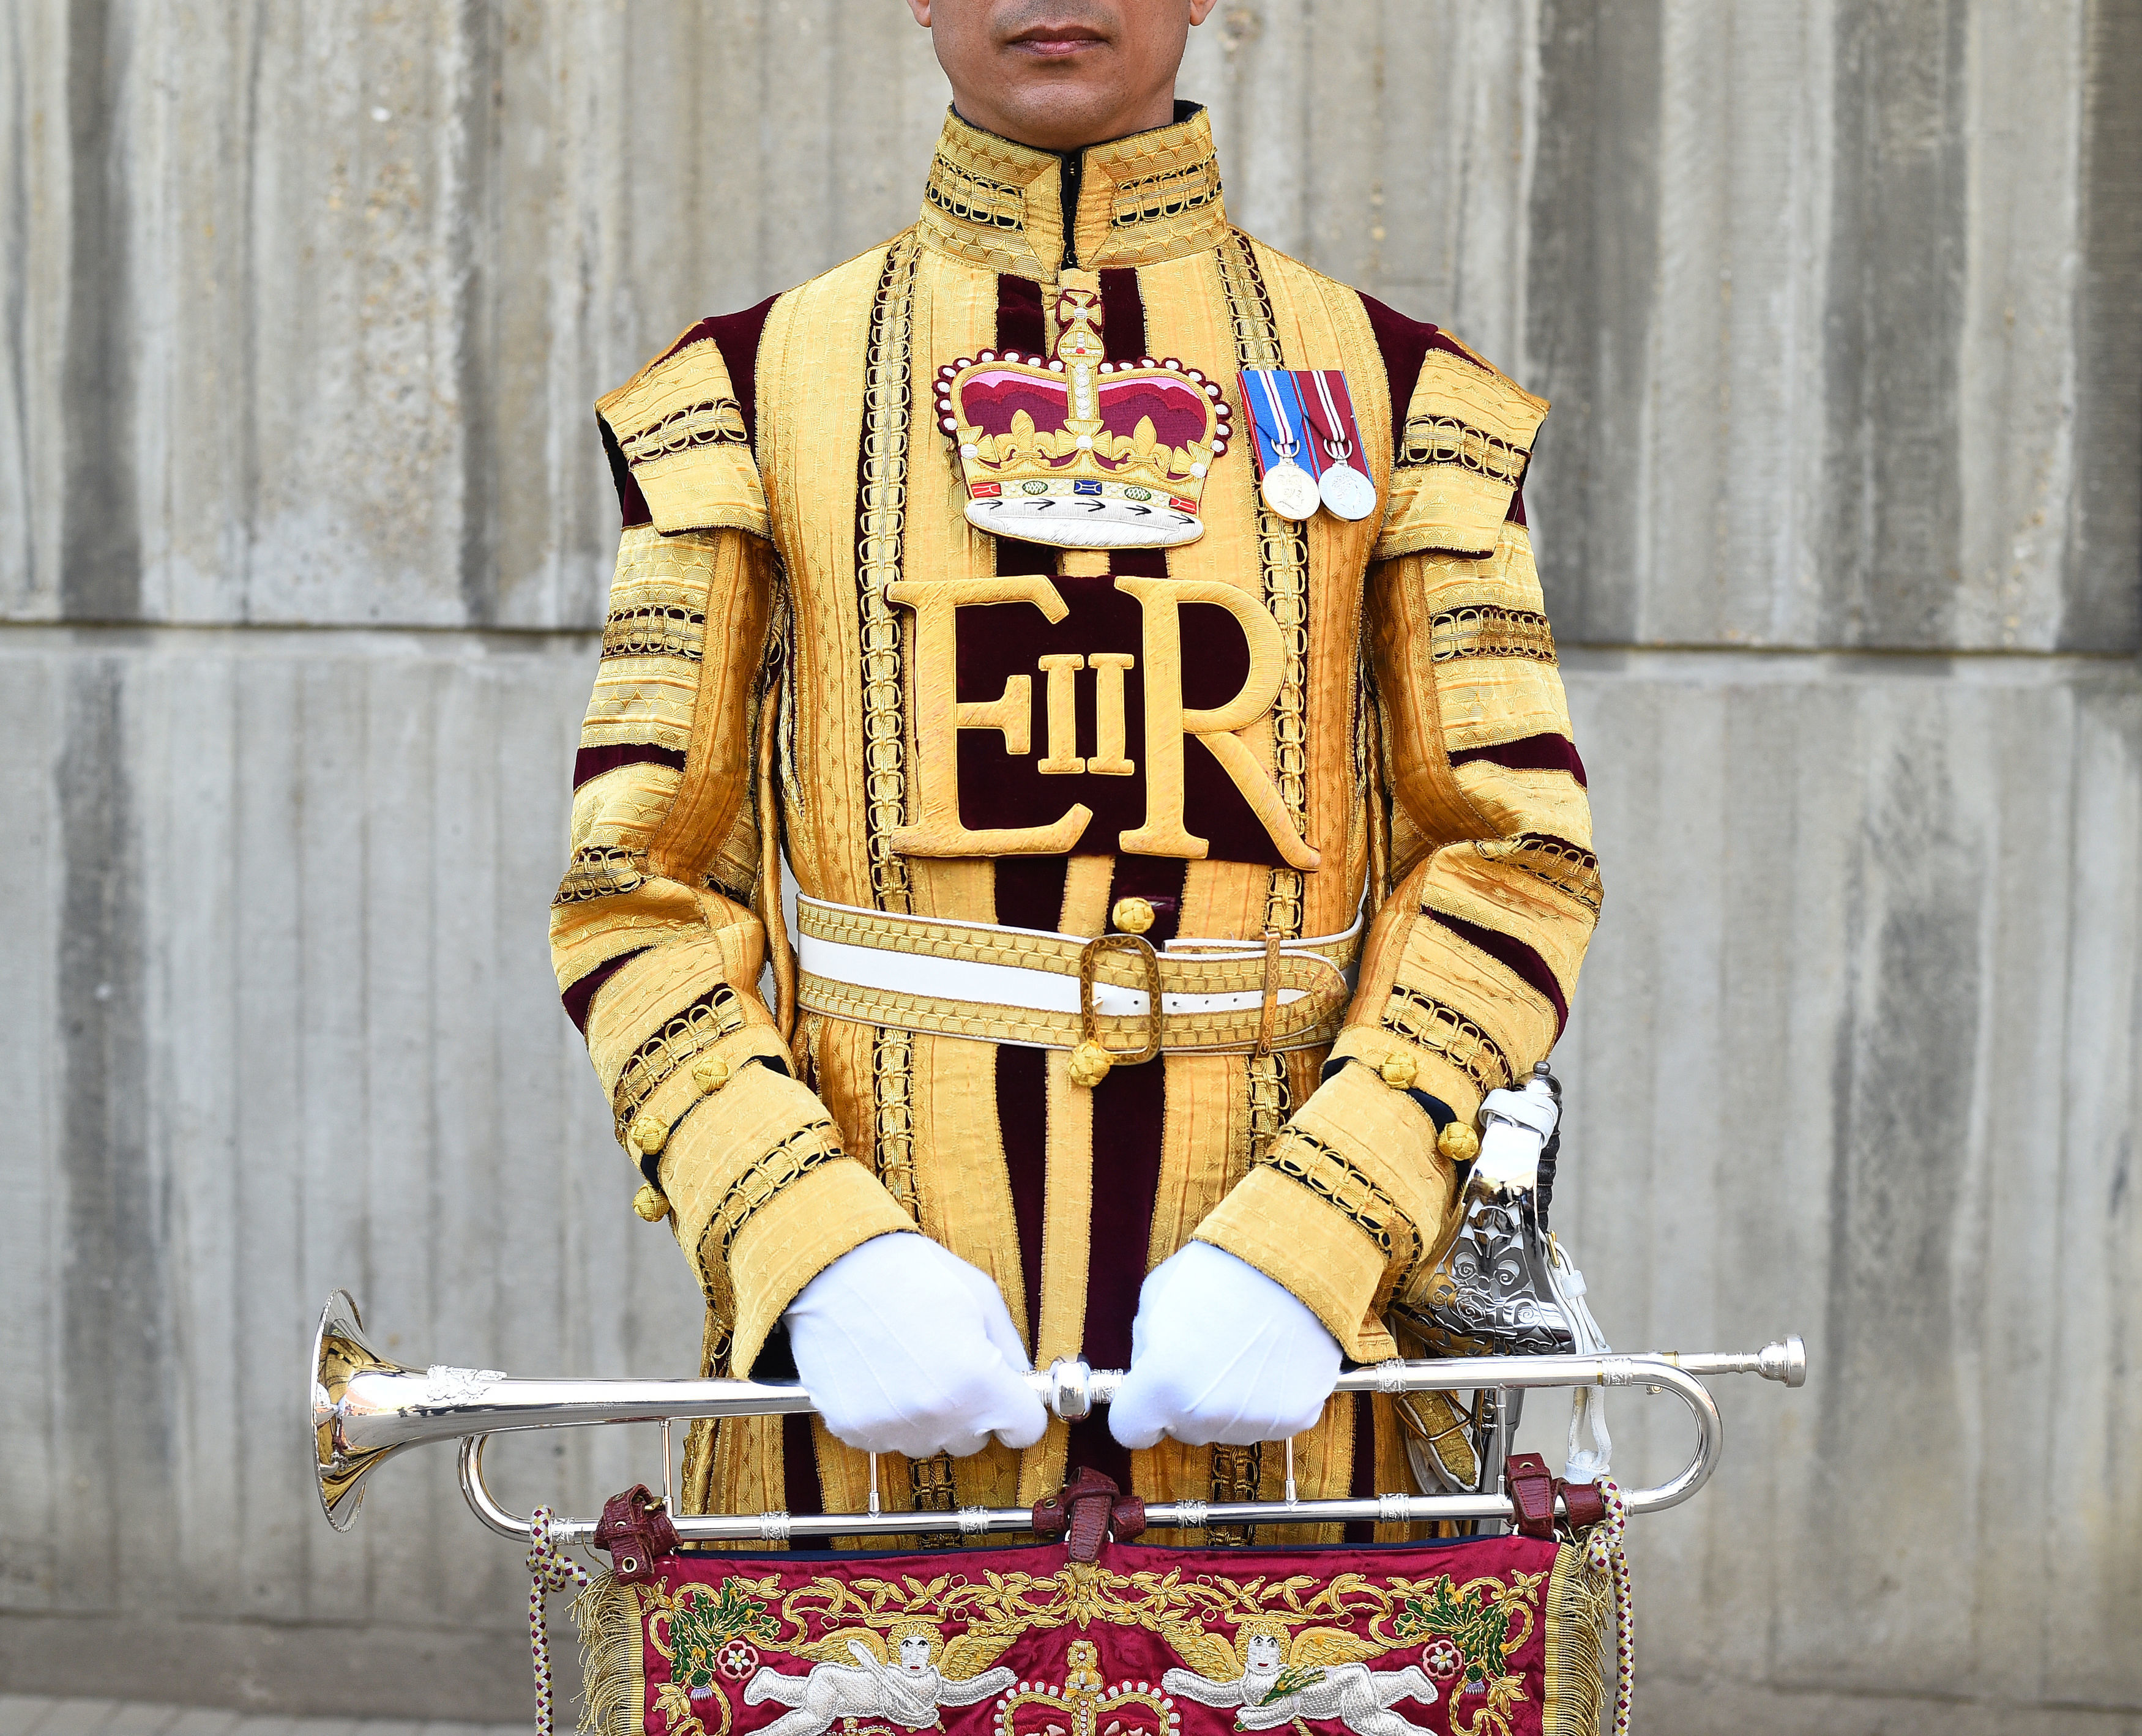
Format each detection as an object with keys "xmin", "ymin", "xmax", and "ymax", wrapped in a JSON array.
[{"xmin": 311, "ymin": 1291, "xmax": 1808, "ymax": 1543}]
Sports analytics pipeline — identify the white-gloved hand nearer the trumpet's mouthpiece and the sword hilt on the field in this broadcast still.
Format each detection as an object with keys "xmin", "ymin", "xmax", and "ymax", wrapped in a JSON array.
[{"xmin": 1108, "ymin": 1242, "xmax": 1339, "ymax": 1447}]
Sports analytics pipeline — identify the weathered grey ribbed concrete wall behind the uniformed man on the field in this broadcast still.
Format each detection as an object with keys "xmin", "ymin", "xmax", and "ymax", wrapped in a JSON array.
[{"xmin": 0, "ymin": 0, "xmax": 2142, "ymax": 1732}]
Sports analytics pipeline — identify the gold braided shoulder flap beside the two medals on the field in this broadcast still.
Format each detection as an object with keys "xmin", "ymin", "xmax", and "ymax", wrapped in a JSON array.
[{"xmin": 1375, "ymin": 334, "xmax": 1547, "ymax": 561}]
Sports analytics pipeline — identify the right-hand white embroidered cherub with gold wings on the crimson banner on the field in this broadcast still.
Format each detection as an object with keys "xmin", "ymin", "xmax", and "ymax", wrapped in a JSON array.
[{"xmin": 1161, "ymin": 1616, "xmax": 1435, "ymax": 1736}]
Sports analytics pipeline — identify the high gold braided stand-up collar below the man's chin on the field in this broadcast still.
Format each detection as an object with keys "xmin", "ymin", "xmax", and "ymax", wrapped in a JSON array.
[{"xmin": 921, "ymin": 103, "xmax": 1228, "ymax": 283}]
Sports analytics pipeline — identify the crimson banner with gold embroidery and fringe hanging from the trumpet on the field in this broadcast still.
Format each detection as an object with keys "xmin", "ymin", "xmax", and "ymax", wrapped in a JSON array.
[{"xmin": 574, "ymin": 1537, "xmax": 1615, "ymax": 1736}]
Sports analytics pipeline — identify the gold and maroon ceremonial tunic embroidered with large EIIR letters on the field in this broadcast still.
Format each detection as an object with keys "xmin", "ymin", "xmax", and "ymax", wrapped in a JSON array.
[{"xmin": 551, "ymin": 111, "xmax": 1600, "ymax": 1511}]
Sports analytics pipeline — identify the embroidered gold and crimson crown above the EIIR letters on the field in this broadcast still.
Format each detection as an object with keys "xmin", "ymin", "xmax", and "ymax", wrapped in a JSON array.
[{"xmin": 936, "ymin": 289, "xmax": 1232, "ymax": 548}]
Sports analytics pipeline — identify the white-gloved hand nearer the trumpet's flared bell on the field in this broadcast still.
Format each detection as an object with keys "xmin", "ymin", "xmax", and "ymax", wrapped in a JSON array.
[{"xmin": 782, "ymin": 1231, "xmax": 1050, "ymax": 1458}]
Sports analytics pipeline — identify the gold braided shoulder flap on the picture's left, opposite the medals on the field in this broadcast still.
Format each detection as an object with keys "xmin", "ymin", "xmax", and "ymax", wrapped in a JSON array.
[{"xmin": 595, "ymin": 319, "xmax": 769, "ymax": 537}]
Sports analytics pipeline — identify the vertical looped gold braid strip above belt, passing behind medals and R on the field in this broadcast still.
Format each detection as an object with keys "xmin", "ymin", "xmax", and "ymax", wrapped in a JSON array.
[{"xmin": 1219, "ymin": 229, "xmax": 1309, "ymax": 936}]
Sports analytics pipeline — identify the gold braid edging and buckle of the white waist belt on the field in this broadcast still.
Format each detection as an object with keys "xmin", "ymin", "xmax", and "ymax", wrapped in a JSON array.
[{"xmin": 797, "ymin": 899, "xmax": 1360, "ymax": 1062}]
